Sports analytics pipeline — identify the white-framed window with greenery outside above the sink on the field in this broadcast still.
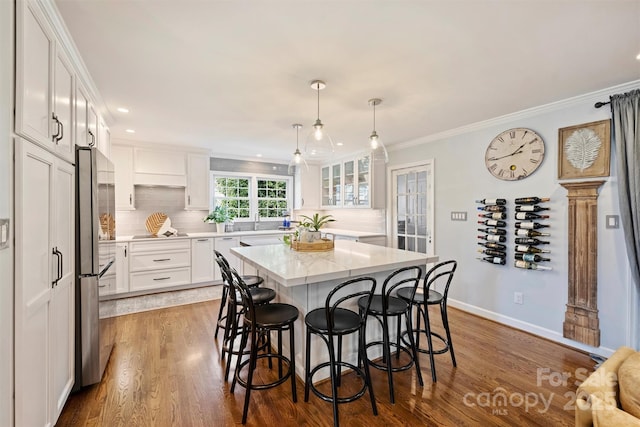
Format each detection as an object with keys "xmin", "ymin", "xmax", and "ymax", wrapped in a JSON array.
[{"xmin": 211, "ymin": 172, "xmax": 293, "ymax": 221}]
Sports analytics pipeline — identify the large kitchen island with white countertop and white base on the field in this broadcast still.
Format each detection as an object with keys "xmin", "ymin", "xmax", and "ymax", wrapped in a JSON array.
[{"xmin": 231, "ymin": 240, "xmax": 438, "ymax": 380}]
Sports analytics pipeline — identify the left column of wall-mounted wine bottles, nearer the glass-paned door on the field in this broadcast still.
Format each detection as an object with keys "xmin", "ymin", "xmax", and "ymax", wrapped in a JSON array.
[{"xmin": 476, "ymin": 199, "xmax": 507, "ymax": 265}]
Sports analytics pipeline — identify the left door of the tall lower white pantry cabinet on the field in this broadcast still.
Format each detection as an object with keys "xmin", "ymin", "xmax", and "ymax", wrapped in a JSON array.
[{"xmin": 14, "ymin": 139, "xmax": 58, "ymax": 426}]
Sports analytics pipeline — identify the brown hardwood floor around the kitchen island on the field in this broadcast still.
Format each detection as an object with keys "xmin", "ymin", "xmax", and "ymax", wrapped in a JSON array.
[{"xmin": 57, "ymin": 301, "xmax": 593, "ymax": 427}]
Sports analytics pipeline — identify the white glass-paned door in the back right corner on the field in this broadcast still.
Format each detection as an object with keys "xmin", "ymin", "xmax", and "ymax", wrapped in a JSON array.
[{"xmin": 391, "ymin": 161, "xmax": 434, "ymax": 254}]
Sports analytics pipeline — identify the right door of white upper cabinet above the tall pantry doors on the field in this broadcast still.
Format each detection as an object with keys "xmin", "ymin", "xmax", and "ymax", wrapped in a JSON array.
[{"xmin": 52, "ymin": 47, "xmax": 75, "ymax": 163}]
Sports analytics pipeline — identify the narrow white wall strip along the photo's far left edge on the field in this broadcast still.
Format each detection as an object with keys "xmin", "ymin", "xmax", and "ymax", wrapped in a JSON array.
[{"xmin": 0, "ymin": 1, "xmax": 14, "ymax": 426}]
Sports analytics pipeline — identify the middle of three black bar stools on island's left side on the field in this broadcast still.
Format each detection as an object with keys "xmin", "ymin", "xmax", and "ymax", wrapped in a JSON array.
[{"xmin": 216, "ymin": 258, "xmax": 276, "ymax": 381}]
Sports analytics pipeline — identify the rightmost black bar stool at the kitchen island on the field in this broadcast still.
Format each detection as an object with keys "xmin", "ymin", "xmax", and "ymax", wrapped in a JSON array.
[{"xmin": 397, "ymin": 260, "xmax": 458, "ymax": 382}]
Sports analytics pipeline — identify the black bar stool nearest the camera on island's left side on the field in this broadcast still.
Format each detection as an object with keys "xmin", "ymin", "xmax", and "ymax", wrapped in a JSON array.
[{"xmin": 231, "ymin": 269, "xmax": 299, "ymax": 424}]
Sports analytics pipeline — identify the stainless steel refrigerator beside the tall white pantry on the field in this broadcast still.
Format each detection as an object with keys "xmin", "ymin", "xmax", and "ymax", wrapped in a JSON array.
[{"xmin": 74, "ymin": 146, "xmax": 116, "ymax": 390}]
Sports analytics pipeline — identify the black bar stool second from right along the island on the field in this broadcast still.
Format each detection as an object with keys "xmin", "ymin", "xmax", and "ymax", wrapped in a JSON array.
[{"xmin": 358, "ymin": 266, "xmax": 424, "ymax": 403}]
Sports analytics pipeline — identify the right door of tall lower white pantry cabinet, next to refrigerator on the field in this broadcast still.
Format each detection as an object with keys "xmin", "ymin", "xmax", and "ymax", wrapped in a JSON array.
[{"xmin": 50, "ymin": 161, "xmax": 75, "ymax": 420}]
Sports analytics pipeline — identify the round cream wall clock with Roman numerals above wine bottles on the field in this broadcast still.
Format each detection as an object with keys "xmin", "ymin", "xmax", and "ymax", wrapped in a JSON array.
[{"xmin": 484, "ymin": 128, "xmax": 544, "ymax": 181}]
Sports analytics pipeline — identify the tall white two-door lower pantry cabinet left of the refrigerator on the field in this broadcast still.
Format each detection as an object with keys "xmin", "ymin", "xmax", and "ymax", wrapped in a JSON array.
[{"xmin": 14, "ymin": 139, "xmax": 75, "ymax": 426}]
